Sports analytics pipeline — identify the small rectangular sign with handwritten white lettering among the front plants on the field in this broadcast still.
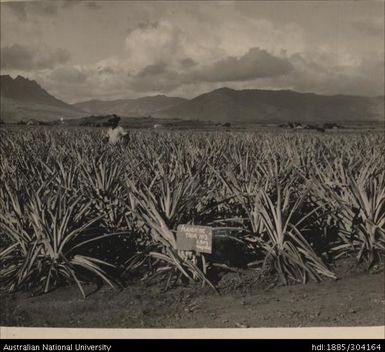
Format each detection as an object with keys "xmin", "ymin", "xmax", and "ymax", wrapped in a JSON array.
[{"xmin": 176, "ymin": 225, "xmax": 213, "ymax": 253}]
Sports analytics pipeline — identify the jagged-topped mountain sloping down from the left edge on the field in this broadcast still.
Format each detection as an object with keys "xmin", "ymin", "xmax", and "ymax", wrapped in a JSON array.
[{"xmin": 0, "ymin": 75, "xmax": 84, "ymax": 123}]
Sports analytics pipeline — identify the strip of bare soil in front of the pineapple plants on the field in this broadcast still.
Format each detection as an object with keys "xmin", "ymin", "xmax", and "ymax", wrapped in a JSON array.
[{"xmin": 0, "ymin": 266, "xmax": 385, "ymax": 328}]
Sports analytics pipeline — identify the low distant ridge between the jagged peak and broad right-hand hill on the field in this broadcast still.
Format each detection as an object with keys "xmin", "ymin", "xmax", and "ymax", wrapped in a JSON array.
[{"xmin": 73, "ymin": 95, "xmax": 187, "ymax": 117}]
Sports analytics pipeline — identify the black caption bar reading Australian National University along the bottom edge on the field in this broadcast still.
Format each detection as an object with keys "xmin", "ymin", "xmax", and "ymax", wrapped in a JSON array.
[{"xmin": 0, "ymin": 339, "xmax": 385, "ymax": 352}]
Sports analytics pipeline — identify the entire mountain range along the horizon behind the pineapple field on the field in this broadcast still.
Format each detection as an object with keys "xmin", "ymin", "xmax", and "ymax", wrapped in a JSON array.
[{"xmin": 0, "ymin": 75, "xmax": 384, "ymax": 123}]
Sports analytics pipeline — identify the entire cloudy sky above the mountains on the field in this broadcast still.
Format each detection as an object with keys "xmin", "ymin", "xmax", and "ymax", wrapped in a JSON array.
[{"xmin": 1, "ymin": 0, "xmax": 384, "ymax": 102}]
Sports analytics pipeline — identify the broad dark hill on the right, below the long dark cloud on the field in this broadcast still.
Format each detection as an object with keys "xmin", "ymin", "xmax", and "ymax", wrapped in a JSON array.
[{"xmin": 154, "ymin": 88, "xmax": 384, "ymax": 123}]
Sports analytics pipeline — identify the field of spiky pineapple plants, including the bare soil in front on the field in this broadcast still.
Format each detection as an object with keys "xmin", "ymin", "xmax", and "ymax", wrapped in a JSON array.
[{"xmin": 0, "ymin": 127, "xmax": 385, "ymax": 327}]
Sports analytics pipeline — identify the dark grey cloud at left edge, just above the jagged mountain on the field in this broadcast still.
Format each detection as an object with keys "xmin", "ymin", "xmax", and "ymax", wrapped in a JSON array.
[{"xmin": 1, "ymin": 44, "xmax": 70, "ymax": 70}]
